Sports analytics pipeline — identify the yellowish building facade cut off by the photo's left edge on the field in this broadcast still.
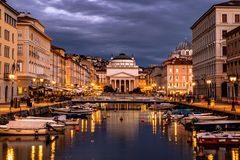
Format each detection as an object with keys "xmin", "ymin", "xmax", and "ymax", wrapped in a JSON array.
[{"xmin": 0, "ymin": 1, "xmax": 19, "ymax": 103}]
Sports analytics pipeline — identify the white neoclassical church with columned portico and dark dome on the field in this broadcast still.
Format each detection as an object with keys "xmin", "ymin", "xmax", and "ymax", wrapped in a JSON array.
[{"xmin": 106, "ymin": 53, "xmax": 139, "ymax": 93}]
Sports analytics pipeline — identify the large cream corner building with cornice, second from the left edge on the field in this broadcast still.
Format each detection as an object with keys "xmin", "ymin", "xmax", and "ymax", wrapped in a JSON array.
[{"xmin": 17, "ymin": 13, "xmax": 52, "ymax": 96}]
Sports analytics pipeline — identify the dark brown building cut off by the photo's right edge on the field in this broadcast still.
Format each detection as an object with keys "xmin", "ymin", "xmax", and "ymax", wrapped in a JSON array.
[{"xmin": 225, "ymin": 27, "xmax": 240, "ymax": 100}]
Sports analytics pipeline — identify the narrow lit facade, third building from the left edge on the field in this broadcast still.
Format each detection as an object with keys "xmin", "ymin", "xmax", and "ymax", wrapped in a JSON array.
[{"xmin": 51, "ymin": 45, "xmax": 66, "ymax": 90}]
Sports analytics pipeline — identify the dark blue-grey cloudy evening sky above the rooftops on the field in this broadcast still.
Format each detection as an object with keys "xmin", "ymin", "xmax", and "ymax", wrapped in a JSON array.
[{"xmin": 7, "ymin": 0, "xmax": 223, "ymax": 66}]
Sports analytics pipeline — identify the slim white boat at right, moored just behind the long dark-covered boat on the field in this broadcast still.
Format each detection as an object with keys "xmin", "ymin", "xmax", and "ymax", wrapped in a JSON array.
[{"xmin": 181, "ymin": 115, "xmax": 228, "ymax": 124}]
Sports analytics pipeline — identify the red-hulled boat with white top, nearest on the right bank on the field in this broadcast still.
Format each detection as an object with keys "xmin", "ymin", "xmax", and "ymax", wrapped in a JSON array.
[{"xmin": 197, "ymin": 131, "xmax": 240, "ymax": 146}]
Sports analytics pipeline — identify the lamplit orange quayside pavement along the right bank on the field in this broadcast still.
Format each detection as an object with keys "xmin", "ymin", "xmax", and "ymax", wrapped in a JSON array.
[{"xmin": 188, "ymin": 102, "xmax": 240, "ymax": 115}]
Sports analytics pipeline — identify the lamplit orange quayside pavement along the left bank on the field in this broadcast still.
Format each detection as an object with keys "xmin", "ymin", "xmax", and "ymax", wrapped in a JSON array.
[{"xmin": 0, "ymin": 102, "xmax": 66, "ymax": 115}]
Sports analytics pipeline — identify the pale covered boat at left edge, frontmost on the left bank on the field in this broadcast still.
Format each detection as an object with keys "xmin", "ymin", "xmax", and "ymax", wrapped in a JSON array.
[{"xmin": 0, "ymin": 121, "xmax": 49, "ymax": 135}]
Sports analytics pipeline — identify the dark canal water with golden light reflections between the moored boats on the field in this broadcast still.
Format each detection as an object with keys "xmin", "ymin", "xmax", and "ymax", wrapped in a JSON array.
[{"xmin": 0, "ymin": 105, "xmax": 239, "ymax": 160}]
